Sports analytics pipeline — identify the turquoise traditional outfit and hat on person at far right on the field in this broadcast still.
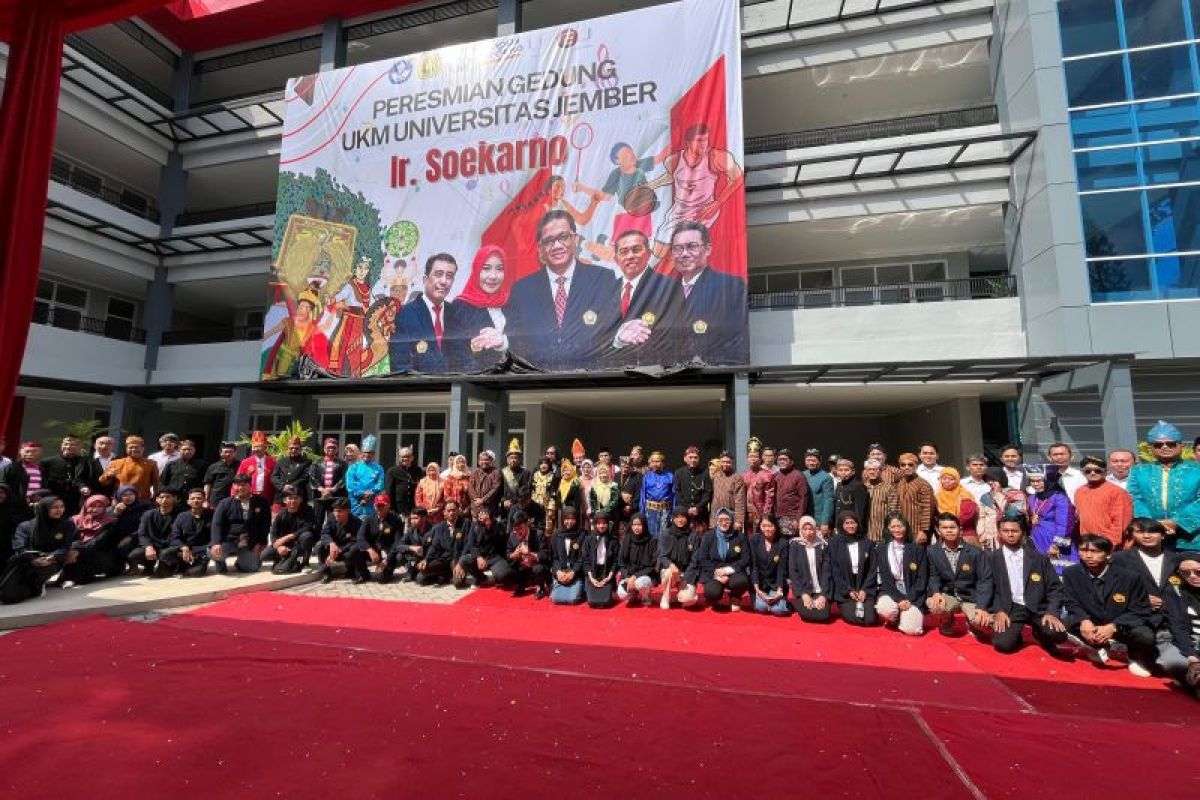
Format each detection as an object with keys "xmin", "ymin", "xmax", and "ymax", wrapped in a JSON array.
[{"xmin": 1126, "ymin": 421, "xmax": 1200, "ymax": 551}]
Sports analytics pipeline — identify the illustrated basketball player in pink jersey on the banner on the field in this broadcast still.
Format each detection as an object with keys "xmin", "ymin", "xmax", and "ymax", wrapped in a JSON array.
[{"xmin": 647, "ymin": 122, "xmax": 743, "ymax": 259}]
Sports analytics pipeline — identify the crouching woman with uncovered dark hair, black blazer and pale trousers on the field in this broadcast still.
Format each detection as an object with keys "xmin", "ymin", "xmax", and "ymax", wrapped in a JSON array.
[{"xmin": 875, "ymin": 513, "xmax": 929, "ymax": 636}]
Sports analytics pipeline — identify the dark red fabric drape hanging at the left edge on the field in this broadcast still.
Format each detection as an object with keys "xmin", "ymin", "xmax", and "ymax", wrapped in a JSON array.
[{"xmin": 0, "ymin": 0, "xmax": 62, "ymax": 431}]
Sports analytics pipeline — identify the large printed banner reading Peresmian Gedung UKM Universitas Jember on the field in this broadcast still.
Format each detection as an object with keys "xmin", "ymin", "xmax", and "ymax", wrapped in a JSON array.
[{"xmin": 262, "ymin": 0, "xmax": 749, "ymax": 380}]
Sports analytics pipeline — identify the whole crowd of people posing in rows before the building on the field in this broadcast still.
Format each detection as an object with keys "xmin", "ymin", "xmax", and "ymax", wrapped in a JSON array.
[{"xmin": 0, "ymin": 421, "xmax": 1200, "ymax": 687}]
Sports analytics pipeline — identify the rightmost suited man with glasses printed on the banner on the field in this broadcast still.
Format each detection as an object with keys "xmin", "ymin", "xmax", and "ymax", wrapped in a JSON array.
[{"xmin": 671, "ymin": 222, "xmax": 750, "ymax": 363}]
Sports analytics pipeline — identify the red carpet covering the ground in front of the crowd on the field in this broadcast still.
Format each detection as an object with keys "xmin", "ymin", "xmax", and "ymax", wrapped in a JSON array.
[{"xmin": 0, "ymin": 591, "xmax": 1200, "ymax": 800}]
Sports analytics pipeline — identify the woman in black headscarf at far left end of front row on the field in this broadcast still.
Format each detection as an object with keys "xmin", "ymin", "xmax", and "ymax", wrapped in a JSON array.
[{"xmin": 0, "ymin": 497, "xmax": 79, "ymax": 603}]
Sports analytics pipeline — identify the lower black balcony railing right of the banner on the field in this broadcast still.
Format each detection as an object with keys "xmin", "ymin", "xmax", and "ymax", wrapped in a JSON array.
[{"xmin": 750, "ymin": 275, "xmax": 1016, "ymax": 311}]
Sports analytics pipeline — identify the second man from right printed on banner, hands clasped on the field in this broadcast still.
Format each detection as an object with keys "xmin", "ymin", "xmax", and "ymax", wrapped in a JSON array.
[{"xmin": 608, "ymin": 230, "xmax": 686, "ymax": 367}]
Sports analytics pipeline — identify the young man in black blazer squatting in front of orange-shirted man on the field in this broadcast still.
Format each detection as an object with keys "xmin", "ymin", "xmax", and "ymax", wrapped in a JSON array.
[{"xmin": 1062, "ymin": 534, "xmax": 1154, "ymax": 678}]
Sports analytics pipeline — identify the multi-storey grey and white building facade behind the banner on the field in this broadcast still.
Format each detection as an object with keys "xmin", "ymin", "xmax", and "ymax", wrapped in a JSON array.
[{"xmin": 7, "ymin": 0, "xmax": 1200, "ymax": 463}]
